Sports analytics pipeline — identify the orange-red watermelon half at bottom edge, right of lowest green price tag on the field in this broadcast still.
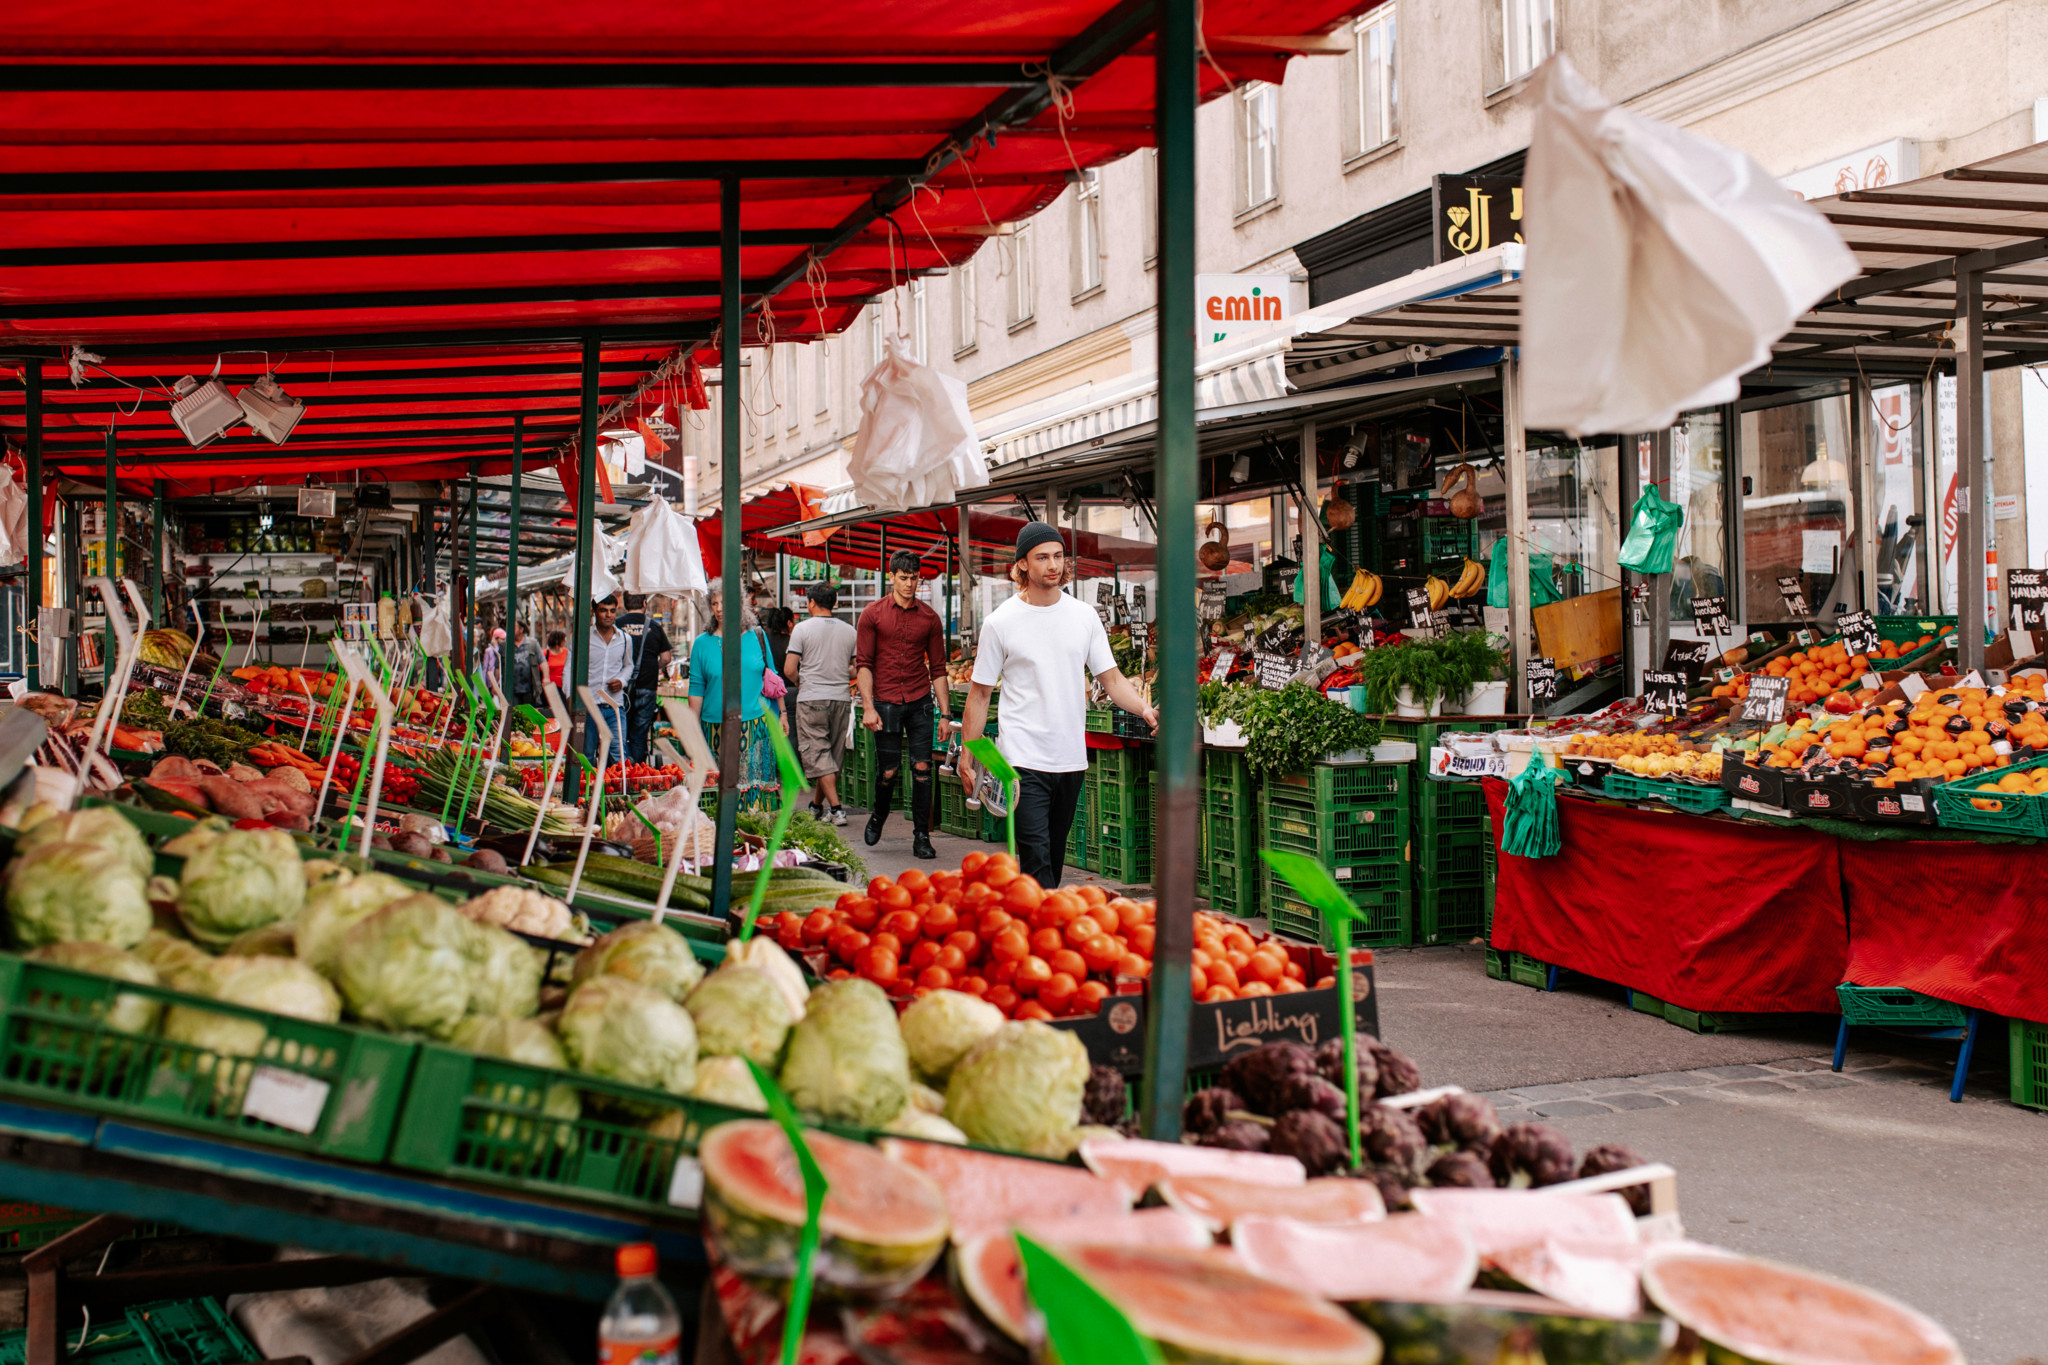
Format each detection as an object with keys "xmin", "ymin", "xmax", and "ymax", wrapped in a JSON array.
[{"xmin": 1061, "ymin": 1246, "xmax": 1380, "ymax": 1365}]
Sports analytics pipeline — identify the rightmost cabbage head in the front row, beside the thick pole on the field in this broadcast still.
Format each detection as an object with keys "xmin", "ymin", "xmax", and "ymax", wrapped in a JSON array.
[{"xmin": 946, "ymin": 1019, "xmax": 1087, "ymax": 1152}]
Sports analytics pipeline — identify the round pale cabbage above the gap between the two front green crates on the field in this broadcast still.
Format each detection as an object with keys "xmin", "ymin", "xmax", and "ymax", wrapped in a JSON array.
[{"xmin": 334, "ymin": 896, "xmax": 477, "ymax": 1038}]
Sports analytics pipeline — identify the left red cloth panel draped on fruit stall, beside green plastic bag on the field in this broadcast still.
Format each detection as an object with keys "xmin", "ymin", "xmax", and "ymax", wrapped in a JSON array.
[{"xmin": 1487, "ymin": 780, "xmax": 1851, "ymax": 1013}]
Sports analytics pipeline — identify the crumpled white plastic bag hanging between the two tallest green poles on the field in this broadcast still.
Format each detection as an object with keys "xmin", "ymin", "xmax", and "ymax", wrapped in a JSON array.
[{"xmin": 848, "ymin": 336, "xmax": 989, "ymax": 512}]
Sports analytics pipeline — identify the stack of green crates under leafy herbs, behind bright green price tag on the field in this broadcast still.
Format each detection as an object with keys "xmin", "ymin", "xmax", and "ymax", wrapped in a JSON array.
[{"xmin": 1257, "ymin": 763, "xmax": 1413, "ymax": 948}]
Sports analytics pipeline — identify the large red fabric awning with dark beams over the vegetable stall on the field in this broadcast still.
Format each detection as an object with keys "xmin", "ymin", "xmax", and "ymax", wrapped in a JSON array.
[{"xmin": 0, "ymin": 0, "xmax": 1374, "ymax": 507}]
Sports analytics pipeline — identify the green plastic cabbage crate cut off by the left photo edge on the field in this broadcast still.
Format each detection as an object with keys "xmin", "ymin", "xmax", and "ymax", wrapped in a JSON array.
[{"xmin": 0, "ymin": 954, "xmax": 418, "ymax": 1162}]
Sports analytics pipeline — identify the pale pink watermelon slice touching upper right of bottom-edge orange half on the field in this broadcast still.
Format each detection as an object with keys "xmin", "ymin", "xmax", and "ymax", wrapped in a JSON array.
[{"xmin": 1231, "ymin": 1214, "xmax": 1479, "ymax": 1304}]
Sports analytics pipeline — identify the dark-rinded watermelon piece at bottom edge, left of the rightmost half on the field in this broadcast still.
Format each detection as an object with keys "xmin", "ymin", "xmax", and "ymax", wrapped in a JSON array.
[{"xmin": 1352, "ymin": 1289, "xmax": 1677, "ymax": 1365}]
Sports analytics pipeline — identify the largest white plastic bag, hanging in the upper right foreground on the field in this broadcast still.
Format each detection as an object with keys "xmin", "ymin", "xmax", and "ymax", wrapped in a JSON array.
[{"xmin": 1522, "ymin": 55, "xmax": 1858, "ymax": 436}]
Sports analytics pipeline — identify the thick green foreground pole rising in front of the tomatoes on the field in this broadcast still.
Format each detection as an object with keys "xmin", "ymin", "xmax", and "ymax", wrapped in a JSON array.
[{"xmin": 1139, "ymin": 0, "xmax": 1202, "ymax": 1142}]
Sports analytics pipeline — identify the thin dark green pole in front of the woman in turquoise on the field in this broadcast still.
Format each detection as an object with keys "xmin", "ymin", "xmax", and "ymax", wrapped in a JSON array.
[{"xmin": 711, "ymin": 180, "xmax": 741, "ymax": 919}]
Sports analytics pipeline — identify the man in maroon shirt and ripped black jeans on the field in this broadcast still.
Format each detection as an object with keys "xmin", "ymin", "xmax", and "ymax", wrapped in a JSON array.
[{"xmin": 854, "ymin": 551, "xmax": 952, "ymax": 857}]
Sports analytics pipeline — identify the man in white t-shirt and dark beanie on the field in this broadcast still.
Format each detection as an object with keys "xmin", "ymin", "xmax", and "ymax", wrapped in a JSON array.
[{"xmin": 961, "ymin": 522, "xmax": 1159, "ymax": 890}]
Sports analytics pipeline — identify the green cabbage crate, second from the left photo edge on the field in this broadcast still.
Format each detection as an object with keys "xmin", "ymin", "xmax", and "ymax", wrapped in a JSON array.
[{"xmin": 391, "ymin": 1044, "xmax": 758, "ymax": 1212}]
